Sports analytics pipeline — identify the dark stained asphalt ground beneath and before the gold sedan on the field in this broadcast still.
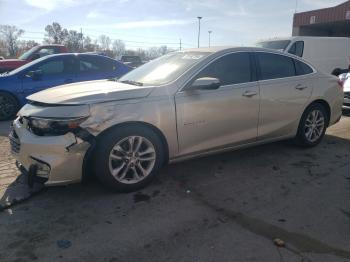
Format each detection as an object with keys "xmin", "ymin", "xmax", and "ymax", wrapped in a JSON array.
[{"xmin": 0, "ymin": 116, "xmax": 350, "ymax": 262}]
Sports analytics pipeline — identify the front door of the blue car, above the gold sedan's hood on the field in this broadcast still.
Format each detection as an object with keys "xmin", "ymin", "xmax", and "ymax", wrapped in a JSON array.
[{"xmin": 22, "ymin": 55, "xmax": 76, "ymax": 96}]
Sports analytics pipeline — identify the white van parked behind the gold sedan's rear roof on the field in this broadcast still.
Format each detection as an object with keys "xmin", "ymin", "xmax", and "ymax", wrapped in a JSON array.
[{"xmin": 257, "ymin": 36, "xmax": 350, "ymax": 75}]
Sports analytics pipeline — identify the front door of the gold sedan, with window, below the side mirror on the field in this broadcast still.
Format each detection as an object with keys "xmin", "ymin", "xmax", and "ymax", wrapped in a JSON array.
[{"xmin": 175, "ymin": 52, "xmax": 259, "ymax": 155}]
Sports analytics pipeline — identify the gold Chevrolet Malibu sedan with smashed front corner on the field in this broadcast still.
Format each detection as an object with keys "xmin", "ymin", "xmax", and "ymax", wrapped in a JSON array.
[{"xmin": 10, "ymin": 48, "xmax": 343, "ymax": 192}]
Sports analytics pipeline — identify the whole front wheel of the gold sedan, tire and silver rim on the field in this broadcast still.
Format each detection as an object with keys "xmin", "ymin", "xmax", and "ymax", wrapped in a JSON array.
[{"xmin": 94, "ymin": 125, "xmax": 164, "ymax": 192}]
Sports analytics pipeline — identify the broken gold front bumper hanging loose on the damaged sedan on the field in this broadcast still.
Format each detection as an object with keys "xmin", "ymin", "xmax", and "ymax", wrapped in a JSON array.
[{"xmin": 9, "ymin": 118, "xmax": 91, "ymax": 186}]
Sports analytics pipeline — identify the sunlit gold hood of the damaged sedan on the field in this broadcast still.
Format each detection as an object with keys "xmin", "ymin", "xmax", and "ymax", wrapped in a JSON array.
[{"xmin": 27, "ymin": 80, "xmax": 153, "ymax": 105}]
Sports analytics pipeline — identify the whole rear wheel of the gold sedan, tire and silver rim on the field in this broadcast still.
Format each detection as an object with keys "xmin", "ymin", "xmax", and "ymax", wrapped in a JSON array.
[{"xmin": 296, "ymin": 104, "xmax": 328, "ymax": 147}]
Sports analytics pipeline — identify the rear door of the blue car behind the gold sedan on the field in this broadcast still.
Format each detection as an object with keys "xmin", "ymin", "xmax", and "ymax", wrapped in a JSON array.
[{"xmin": 77, "ymin": 55, "xmax": 117, "ymax": 81}]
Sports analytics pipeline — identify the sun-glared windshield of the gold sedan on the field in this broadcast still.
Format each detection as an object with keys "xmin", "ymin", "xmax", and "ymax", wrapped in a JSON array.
[{"xmin": 119, "ymin": 52, "xmax": 211, "ymax": 85}]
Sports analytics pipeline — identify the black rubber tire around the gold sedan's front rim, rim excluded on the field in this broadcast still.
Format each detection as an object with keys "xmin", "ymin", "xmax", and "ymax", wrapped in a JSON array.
[{"xmin": 93, "ymin": 124, "xmax": 164, "ymax": 192}]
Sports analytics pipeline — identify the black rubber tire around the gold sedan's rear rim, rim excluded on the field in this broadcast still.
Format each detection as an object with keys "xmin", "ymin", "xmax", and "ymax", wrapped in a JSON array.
[{"xmin": 295, "ymin": 103, "xmax": 329, "ymax": 147}]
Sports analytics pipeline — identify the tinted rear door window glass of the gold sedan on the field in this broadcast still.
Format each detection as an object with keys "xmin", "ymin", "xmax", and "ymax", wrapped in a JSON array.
[{"xmin": 257, "ymin": 52, "xmax": 296, "ymax": 80}]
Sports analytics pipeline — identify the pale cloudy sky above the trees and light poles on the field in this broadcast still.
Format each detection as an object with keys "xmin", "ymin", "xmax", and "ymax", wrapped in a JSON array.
[{"xmin": 0, "ymin": 0, "xmax": 345, "ymax": 48}]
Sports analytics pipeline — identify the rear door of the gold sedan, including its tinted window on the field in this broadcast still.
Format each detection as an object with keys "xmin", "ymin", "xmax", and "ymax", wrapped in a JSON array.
[{"xmin": 255, "ymin": 52, "xmax": 313, "ymax": 140}]
